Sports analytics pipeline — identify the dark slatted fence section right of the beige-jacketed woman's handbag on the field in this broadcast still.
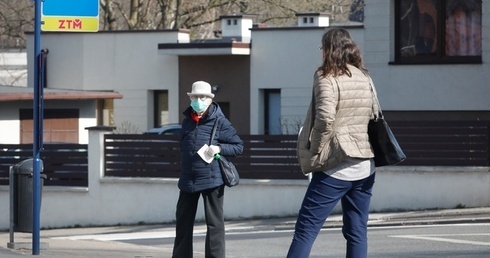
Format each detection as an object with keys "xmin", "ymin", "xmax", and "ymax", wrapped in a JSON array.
[{"xmin": 389, "ymin": 121, "xmax": 490, "ymax": 166}]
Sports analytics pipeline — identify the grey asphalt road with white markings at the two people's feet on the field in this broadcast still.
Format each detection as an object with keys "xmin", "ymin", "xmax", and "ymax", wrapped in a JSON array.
[{"xmin": 0, "ymin": 207, "xmax": 490, "ymax": 258}]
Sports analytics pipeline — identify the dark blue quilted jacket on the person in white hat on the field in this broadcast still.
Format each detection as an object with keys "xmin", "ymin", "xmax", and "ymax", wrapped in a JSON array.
[{"xmin": 179, "ymin": 102, "xmax": 243, "ymax": 193}]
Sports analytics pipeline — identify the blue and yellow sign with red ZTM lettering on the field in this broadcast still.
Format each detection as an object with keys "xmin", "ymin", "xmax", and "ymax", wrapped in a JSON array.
[{"xmin": 41, "ymin": 0, "xmax": 99, "ymax": 32}]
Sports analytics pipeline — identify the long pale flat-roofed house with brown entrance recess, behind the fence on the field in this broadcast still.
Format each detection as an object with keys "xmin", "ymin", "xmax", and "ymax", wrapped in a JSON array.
[{"xmin": 24, "ymin": 1, "xmax": 490, "ymax": 134}]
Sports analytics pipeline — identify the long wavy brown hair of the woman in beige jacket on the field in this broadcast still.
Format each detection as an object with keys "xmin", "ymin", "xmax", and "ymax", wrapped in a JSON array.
[{"xmin": 318, "ymin": 28, "xmax": 368, "ymax": 77}]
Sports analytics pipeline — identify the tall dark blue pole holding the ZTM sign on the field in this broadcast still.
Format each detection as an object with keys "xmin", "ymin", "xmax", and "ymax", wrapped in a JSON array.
[{"xmin": 32, "ymin": 0, "xmax": 43, "ymax": 255}]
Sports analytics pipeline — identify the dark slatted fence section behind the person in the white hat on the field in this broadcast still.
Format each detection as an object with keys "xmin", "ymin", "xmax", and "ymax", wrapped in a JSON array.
[{"xmin": 104, "ymin": 134, "xmax": 304, "ymax": 179}]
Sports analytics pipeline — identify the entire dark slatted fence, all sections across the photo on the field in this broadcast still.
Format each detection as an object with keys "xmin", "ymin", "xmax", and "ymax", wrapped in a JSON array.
[{"xmin": 0, "ymin": 121, "xmax": 490, "ymax": 186}]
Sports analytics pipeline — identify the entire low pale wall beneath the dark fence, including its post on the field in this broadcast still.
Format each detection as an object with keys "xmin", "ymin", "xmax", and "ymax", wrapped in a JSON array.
[{"xmin": 0, "ymin": 131, "xmax": 490, "ymax": 230}]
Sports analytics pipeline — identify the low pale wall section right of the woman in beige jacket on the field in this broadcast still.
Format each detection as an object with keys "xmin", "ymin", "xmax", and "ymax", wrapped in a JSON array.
[{"xmin": 370, "ymin": 166, "xmax": 490, "ymax": 211}]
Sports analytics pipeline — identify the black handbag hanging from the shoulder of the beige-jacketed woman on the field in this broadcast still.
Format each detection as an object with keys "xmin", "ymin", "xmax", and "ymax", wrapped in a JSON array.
[{"xmin": 368, "ymin": 79, "xmax": 407, "ymax": 167}]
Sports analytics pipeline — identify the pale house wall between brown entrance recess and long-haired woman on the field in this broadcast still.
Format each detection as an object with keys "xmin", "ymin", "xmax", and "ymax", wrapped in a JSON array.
[{"xmin": 250, "ymin": 27, "xmax": 364, "ymax": 134}]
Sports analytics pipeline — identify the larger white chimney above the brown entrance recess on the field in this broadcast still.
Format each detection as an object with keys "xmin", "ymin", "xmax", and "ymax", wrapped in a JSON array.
[{"xmin": 220, "ymin": 15, "xmax": 253, "ymax": 43}]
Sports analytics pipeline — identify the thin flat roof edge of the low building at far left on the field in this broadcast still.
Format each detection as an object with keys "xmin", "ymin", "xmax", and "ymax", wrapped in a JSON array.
[{"xmin": 0, "ymin": 86, "xmax": 123, "ymax": 102}]
